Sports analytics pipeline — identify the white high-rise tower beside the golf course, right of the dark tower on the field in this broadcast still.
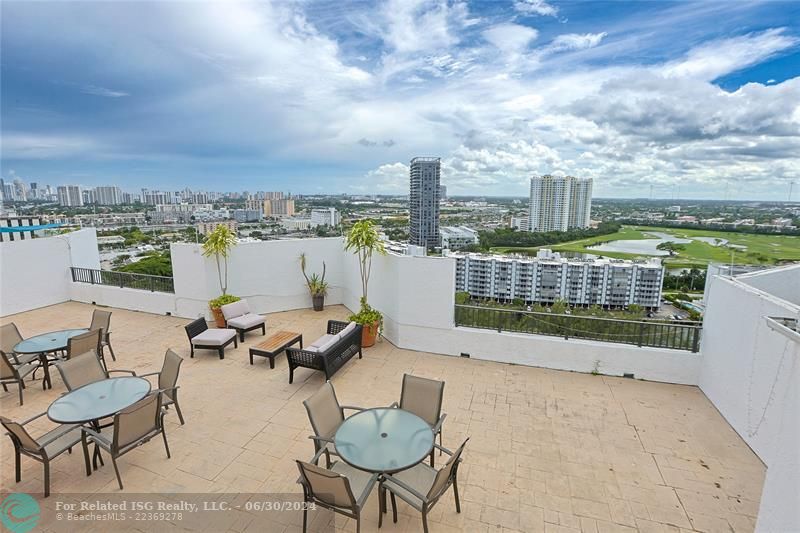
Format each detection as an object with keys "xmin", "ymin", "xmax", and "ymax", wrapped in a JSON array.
[{"xmin": 528, "ymin": 175, "xmax": 592, "ymax": 232}]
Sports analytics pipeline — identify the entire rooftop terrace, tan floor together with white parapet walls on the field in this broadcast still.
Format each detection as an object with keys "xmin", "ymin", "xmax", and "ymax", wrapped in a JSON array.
[{"xmin": 0, "ymin": 230, "xmax": 800, "ymax": 532}]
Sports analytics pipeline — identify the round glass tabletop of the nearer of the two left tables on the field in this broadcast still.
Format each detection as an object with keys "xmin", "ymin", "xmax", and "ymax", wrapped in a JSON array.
[{"xmin": 47, "ymin": 377, "xmax": 150, "ymax": 424}]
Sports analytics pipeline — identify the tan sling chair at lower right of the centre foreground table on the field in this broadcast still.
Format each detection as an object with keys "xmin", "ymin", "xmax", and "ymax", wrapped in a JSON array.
[{"xmin": 378, "ymin": 438, "xmax": 469, "ymax": 533}]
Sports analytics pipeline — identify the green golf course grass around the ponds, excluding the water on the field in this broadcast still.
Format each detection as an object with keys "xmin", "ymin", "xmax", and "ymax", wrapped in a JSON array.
[{"xmin": 500, "ymin": 226, "xmax": 800, "ymax": 268}]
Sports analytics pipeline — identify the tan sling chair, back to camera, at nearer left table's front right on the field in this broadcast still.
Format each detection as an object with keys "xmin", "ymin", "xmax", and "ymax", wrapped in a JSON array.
[{"xmin": 81, "ymin": 391, "xmax": 171, "ymax": 490}]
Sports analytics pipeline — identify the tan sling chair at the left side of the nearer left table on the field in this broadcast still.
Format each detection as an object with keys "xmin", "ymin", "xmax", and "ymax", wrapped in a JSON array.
[{"xmin": 0, "ymin": 412, "xmax": 81, "ymax": 498}]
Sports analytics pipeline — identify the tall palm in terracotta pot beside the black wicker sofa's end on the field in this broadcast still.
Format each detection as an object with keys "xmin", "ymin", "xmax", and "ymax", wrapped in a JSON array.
[{"xmin": 344, "ymin": 220, "xmax": 386, "ymax": 347}]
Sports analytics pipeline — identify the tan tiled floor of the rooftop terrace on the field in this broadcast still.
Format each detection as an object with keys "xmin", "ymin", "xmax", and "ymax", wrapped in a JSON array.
[{"xmin": 0, "ymin": 302, "xmax": 765, "ymax": 533}]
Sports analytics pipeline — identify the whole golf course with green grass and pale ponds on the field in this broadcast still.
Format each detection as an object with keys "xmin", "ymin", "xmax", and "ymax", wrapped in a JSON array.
[{"xmin": 492, "ymin": 226, "xmax": 800, "ymax": 269}]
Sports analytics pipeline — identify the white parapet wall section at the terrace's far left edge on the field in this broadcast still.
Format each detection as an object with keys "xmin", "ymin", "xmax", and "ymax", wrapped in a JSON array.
[{"xmin": 0, "ymin": 228, "xmax": 100, "ymax": 316}]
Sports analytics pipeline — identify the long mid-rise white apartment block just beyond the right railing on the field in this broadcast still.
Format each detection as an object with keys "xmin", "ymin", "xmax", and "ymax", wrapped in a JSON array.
[{"xmin": 448, "ymin": 250, "xmax": 664, "ymax": 309}]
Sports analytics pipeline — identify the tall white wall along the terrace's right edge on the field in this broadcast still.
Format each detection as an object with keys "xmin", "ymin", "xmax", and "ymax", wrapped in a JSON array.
[{"xmin": 700, "ymin": 265, "xmax": 800, "ymax": 533}]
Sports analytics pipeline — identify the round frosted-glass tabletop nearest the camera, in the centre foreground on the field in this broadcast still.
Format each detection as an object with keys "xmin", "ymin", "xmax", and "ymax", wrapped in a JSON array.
[{"xmin": 333, "ymin": 407, "xmax": 433, "ymax": 474}]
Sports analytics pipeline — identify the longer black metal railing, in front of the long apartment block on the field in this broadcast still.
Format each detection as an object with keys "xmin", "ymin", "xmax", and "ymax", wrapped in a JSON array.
[{"xmin": 455, "ymin": 304, "xmax": 703, "ymax": 352}]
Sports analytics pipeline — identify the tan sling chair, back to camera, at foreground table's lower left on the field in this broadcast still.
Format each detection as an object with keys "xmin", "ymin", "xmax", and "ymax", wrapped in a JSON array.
[{"xmin": 297, "ymin": 450, "xmax": 380, "ymax": 533}]
